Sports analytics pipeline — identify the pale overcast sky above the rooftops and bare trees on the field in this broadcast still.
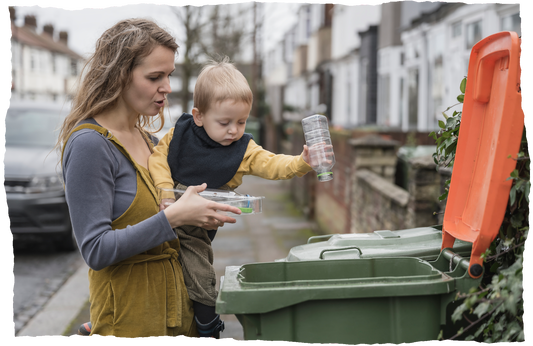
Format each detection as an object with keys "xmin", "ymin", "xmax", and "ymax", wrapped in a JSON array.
[{"xmin": 15, "ymin": 0, "xmax": 302, "ymax": 60}]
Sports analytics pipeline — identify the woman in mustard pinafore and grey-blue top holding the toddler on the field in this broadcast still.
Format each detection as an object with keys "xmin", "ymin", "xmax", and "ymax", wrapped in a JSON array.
[{"xmin": 57, "ymin": 19, "xmax": 240, "ymax": 340}]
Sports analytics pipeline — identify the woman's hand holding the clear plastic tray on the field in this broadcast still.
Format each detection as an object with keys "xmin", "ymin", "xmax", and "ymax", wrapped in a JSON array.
[{"xmin": 164, "ymin": 183, "xmax": 241, "ymax": 229}]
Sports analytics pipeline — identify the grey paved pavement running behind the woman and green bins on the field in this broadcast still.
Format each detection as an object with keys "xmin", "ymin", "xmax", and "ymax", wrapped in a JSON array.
[{"xmin": 16, "ymin": 176, "xmax": 316, "ymax": 343}]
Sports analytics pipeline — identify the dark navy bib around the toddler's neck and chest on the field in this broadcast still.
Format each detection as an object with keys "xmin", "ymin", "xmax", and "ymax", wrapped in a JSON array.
[{"xmin": 168, "ymin": 113, "xmax": 253, "ymax": 189}]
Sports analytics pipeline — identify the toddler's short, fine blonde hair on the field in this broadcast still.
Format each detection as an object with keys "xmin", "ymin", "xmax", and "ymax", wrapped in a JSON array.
[{"xmin": 193, "ymin": 56, "xmax": 253, "ymax": 114}]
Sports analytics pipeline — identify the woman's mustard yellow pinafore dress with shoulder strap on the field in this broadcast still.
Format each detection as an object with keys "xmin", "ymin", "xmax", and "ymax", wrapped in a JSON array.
[{"xmin": 60, "ymin": 124, "xmax": 198, "ymax": 340}]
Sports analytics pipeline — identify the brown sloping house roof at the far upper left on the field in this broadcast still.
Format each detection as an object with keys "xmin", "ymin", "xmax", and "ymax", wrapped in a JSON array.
[{"xmin": 7, "ymin": 21, "xmax": 85, "ymax": 60}]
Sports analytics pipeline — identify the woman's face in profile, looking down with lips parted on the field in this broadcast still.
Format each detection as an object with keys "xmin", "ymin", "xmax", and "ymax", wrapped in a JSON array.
[{"xmin": 122, "ymin": 46, "xmax": 174, "ymax": 116}]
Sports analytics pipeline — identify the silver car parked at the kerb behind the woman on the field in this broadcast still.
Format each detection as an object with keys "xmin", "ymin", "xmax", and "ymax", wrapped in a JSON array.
[{"xmin": 2, "ymin": 101, "xmax": 77, "ymax": 251}]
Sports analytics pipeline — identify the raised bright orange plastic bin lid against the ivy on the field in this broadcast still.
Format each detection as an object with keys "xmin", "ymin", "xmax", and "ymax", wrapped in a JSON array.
[{"xmin": 442, "ymin": 31, "xmax": 527, "ymax": 278}]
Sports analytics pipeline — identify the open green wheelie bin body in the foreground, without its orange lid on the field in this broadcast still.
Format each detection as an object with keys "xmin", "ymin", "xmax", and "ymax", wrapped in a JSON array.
[{"xmin": 216, "ymin": 249, "xmax": 480, "ymax": 345}]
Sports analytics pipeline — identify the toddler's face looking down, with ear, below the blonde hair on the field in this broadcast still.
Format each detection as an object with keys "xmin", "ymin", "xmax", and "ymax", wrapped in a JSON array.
[{"xmin": 192, "ymin": 100, "xmax": 251, "ymax": 146}]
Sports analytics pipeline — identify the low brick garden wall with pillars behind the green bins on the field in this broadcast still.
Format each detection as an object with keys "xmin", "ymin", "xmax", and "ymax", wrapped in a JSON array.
[{"xmin": 282, "ymin": 123, "xmax": 448, "ymax": 234}]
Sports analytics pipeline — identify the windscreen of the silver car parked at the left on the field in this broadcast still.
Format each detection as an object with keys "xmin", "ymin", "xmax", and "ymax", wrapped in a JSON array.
[{"xmin": 2, "ymin": 107, "xmax": 65, "ymax": 147}]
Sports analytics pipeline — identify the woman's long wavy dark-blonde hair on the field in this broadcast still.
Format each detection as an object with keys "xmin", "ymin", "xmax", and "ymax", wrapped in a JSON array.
[{"xmin": 55, "ymin": 19, "xmax": 178, "ymax": 154}]
